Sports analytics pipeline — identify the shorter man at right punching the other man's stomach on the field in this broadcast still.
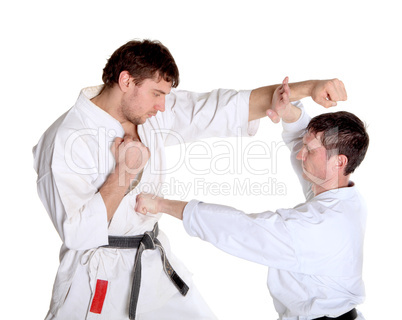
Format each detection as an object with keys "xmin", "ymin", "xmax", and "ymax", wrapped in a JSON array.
[{"xmin": 136, "ymin": 79, "xmax": 369, "ymax": 320}]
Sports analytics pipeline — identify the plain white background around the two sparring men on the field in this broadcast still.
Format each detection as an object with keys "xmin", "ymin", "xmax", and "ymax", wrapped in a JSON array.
[{"xmin": 0, "ymin": 0, "xmax": 402, "ymax": 319}]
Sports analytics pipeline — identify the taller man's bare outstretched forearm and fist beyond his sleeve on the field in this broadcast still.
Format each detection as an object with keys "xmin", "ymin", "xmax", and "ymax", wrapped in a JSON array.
[{"xmin": 249, "ymin": 79, "xmax": 347, "ymax": 121}]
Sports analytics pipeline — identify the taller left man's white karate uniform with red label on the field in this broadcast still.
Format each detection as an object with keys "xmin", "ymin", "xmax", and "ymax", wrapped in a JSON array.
[{"xmin": 33, "ymin": 86, "xmax": 258, "ymax": 320}]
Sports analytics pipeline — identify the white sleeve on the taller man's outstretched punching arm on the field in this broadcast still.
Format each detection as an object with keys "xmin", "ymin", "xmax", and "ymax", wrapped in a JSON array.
[{"xmin": 164, "ymin": 89, "xmax": 259, "ymax": 145}]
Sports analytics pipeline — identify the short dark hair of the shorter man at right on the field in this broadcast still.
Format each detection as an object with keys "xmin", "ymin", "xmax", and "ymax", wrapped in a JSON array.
[{"xmin": 307, "ymin": 111, "xmax": 369, "ymax": 176}]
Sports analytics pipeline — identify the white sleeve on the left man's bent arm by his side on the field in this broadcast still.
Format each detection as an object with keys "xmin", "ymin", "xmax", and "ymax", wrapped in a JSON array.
[{"xmin": 37, "ymin": 129, "xmax": 108, "ymax": 250}]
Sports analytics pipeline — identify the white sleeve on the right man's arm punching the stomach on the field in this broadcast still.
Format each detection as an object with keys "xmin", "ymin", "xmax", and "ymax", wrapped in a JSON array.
[{"xmin": 183, "ymin": 200, "xmax": 299, "ymax": 271}]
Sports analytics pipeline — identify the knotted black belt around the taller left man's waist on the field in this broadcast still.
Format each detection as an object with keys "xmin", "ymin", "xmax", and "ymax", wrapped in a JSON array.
[{"xmin": 103, "ymin": 223, "xmax": 189, "ymax": 319}]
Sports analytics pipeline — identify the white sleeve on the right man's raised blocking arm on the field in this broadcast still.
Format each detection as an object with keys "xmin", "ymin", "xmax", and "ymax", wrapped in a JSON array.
[{"xmin": 282, "ymin": 101, "xmax": 314, "ymax": 200}]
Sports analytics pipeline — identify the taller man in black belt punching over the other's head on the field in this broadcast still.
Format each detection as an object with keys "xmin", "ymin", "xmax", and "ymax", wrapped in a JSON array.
[{"xmin": 33, "ymin": 40, "xmax": 346, "ymax": 320}]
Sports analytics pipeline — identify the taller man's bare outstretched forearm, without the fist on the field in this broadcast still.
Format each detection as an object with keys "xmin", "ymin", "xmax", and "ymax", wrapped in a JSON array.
[{"xmin": 249, "ymin": 80, "xmax": 317, "ymax": 121}]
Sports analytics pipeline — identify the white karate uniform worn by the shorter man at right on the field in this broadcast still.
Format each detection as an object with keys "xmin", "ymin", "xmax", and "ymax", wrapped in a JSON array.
[{"xmin": 183, "ymin": 102, "xmax": 367, "ymax": 320}]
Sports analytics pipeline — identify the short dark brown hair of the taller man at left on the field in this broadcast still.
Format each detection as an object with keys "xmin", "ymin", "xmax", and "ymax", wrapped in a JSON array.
[{"xmin": 102, "ymin": 40, "xmax": 179, "ymax": 88}]
